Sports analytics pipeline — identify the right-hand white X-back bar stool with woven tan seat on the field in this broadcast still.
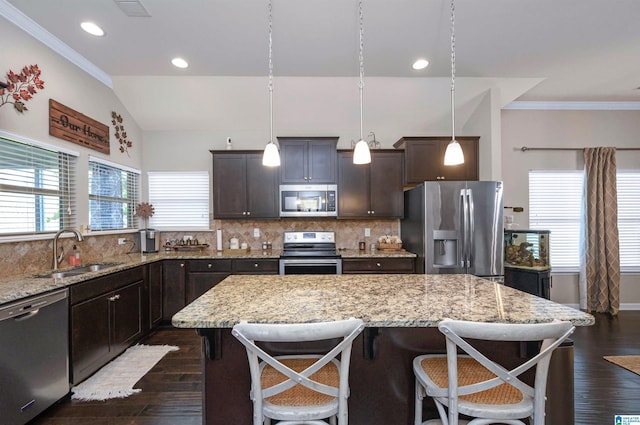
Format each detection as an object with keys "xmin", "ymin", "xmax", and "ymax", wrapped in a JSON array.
[{"xmin": 413, "ymin": 319, "xmax": 575, "ymax": 425}]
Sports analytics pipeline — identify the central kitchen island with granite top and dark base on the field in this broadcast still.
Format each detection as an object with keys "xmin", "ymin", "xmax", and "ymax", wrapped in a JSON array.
[{"xmin": 172, "ymin": 274, "xmax": 594, "ymax": 425}]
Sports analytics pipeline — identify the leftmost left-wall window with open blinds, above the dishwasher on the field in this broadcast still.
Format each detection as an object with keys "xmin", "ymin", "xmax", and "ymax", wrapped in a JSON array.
[{"xmin": 0, "ymin": 132, "xmax": 78, "ymax": 237}]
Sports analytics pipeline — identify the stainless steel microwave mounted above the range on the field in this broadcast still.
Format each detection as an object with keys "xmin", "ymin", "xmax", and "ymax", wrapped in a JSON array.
[{"xmin": 280, "ymin": 184, "xmax": 338, "ymax": 217}]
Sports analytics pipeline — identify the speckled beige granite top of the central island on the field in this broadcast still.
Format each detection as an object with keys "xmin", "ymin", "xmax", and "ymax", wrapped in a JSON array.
[{"xmin": 172, "ymin": 274, "xmax": 594, "ymax": 329}]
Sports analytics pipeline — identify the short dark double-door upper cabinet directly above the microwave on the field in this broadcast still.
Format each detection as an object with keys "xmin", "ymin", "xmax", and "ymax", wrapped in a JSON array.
[{"xmin": 278, "ymin": 137, "xmax": 338, "ymax": 184}]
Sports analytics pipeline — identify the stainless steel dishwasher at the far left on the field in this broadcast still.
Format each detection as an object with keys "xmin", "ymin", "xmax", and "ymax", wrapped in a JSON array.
[{"xmin": 0, "ymin": 289, "xmax": 70, "ymax": 425}]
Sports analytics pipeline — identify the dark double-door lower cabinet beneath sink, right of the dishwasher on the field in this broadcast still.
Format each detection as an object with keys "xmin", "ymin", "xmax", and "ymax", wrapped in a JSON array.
[{"xmin": 70, "ymin": 267, "xmax": 148, "ymax": 385}]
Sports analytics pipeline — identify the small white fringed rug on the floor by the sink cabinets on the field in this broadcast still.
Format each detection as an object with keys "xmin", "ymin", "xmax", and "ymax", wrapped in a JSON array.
[{"xmin": 71, "ymin": 345, "xmax": 178, "ymax": 401}]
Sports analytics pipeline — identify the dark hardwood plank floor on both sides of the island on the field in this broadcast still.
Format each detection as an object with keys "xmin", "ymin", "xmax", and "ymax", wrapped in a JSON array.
[{"xmin": 29, "ymin": 311, "xmax": 640, "ymax": 425}]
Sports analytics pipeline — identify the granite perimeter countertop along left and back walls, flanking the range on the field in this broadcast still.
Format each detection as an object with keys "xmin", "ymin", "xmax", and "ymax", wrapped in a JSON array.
[{"xmin": 0, "ymin": 249, "xmax": 415, "ymax": 305}]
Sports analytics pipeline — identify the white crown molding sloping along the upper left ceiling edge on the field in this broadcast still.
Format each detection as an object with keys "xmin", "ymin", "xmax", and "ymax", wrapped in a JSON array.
[{"xmin": 0, "ymin": 0, "xmax": 113, "ymax": 89}]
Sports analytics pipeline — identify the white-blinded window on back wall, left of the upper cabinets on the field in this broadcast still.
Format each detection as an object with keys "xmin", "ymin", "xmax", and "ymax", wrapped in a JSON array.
[{"xmin": 148, "ymin": 171, "xmax": 209, "ymax": 230}]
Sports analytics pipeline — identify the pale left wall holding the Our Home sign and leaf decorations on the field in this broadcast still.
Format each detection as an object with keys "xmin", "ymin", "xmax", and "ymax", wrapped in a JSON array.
[{"xmin": 0, "ymin": 17, "xmax": 142, "ymax": 232}]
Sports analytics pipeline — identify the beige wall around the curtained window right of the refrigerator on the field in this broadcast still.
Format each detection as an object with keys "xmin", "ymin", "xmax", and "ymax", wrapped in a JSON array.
[{"xmin": 502, "ymin": 110, "xmax": 640, "ymax": 308}]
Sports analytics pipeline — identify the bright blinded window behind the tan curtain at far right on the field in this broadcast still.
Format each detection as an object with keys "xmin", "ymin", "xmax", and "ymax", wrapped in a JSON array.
[{"xmin": 529, "ymin": 170, "xmax": 640, "ymax": 273}]
